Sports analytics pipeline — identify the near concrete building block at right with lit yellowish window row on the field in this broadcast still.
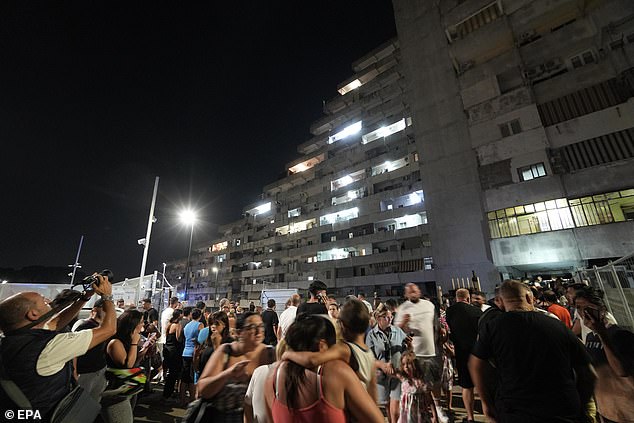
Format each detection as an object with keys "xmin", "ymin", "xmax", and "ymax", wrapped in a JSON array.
[{"xmin": 393, "ymin": 0, "xmax": 634, "ymax": 284}]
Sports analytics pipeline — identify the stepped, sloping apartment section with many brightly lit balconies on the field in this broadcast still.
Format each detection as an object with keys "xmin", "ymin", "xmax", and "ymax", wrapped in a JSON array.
[{"xmin": 165, "ymin": 40, "xmax": 436, "ymax": 304}]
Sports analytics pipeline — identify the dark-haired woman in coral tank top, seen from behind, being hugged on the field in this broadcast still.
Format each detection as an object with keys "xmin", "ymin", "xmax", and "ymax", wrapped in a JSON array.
[{"xmin": 264, "ymin": 314, "xmax": 384, "ymax": 423}]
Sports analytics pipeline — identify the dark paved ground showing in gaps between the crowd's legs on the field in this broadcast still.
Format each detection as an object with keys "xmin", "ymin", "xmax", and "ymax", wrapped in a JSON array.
[{"xmin": 134, "ymin": 384, "xmax": 485, "ymax": 423}]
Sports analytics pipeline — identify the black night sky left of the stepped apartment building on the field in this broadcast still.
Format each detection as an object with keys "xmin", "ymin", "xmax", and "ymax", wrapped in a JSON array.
[{"xmin": 0, "ymin": 0, "xmax": 396, "ymax": 280}]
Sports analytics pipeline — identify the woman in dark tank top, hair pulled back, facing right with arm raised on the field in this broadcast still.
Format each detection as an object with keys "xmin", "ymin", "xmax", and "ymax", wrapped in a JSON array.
[{"xmin": 198, "ymin": 311, "xmax": 272, "ymax": 423}]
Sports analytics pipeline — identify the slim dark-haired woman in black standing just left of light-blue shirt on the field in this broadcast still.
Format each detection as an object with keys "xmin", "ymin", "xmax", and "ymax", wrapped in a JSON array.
[{"xmin": 163, "ymin": 309, "xmax": 185, "ymax": 399}]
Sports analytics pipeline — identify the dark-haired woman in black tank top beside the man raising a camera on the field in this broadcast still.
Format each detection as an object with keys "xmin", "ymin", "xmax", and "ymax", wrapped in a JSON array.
[{"xmin": 101, "ymin": 310, "xmax": 153, "ymax": 423}]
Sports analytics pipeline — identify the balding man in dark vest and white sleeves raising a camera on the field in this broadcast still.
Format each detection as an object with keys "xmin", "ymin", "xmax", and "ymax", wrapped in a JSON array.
[{"xmin": 0, "ymin": 272, "xmax": 116, "ymax": 420}]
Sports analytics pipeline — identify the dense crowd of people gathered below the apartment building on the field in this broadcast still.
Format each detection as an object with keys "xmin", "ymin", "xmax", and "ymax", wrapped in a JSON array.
[{"xmin": 0, "ymin": 275, "xmax": 634, "ymax": 423}]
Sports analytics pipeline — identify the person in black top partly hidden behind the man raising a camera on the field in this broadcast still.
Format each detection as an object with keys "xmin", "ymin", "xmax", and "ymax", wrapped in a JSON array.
[{"xmin": 73, "ymin": 299, "xmax": 108, "ymax": 401}]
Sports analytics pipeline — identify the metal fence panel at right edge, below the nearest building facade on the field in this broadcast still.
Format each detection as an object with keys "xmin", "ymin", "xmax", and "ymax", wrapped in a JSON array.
[{"xmin": 579, "ymin": 253, "xmax": 634, "ymax": 330}]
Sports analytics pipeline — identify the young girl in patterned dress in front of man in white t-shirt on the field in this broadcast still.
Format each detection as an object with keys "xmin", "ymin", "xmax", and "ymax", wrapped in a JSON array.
[{"xmin": 397, "ymin": 351, "xmax": 438, "ymax": 423}]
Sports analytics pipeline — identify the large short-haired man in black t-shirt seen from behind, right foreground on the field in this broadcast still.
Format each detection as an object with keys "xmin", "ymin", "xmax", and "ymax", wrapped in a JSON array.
[{"xmin": 469, "ymin": 281, "xmax": 595, "ymax": 423}]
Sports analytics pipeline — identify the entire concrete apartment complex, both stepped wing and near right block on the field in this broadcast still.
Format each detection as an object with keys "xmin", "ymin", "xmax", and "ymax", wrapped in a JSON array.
[{"xmin": 167, "ymin": 0, "xmax": 634, "ymax": 304}]
